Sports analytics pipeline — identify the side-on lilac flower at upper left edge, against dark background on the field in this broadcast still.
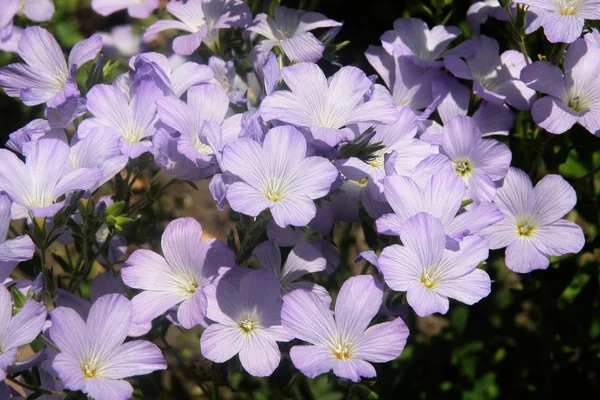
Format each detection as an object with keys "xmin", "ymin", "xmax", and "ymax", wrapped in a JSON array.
[{"xmin": 0, "ymin": 26, "xmax": 102, "ymax": 107}]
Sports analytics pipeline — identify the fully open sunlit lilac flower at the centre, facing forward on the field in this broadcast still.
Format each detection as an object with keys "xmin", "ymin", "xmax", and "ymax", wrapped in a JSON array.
[{"xmin": 221, "ymin": 126, "xmax": 338, "ymax": 227}]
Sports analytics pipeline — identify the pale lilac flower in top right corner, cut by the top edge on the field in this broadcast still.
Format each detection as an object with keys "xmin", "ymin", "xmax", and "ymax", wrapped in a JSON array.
[{"xmin": 515, "ymin": 0, "xmax": 600, "ymax": 43}]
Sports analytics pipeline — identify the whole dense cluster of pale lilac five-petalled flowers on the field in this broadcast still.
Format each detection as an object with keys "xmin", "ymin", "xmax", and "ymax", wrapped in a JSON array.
[{"xmin": 0, "ymin": 0, "xmax": 600, "ymax": 400}]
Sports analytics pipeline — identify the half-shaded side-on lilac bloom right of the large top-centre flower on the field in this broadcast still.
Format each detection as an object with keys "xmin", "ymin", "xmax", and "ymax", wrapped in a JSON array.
[{"xmin": 365, "ymin": 46, "xmax": 440, "ymax": 111}]
